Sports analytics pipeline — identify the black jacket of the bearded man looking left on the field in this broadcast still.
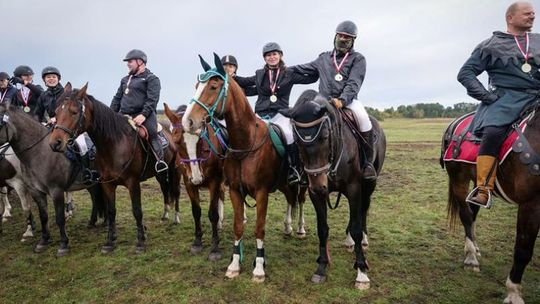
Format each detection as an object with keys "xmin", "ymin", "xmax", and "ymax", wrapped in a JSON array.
[{"xmin": 111, "ymin": 69, "xmax": 161, "ymax": 118}]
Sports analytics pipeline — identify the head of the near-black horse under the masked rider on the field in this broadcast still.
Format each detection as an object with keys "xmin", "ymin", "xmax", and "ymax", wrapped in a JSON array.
[{"xmin": 280, "ymin": 90, "xmax": 338, "ymax": 195}]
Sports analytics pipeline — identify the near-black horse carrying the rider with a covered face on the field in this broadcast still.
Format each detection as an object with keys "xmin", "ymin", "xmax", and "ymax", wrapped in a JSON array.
[{"xmin": 280, "ymin": 90, "xmax": 386, "ymax": 290}]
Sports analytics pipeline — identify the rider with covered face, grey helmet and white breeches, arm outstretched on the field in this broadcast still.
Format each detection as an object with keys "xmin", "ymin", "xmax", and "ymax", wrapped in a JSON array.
[{"xmin": 291, "ymin": 21, "xmax": 377, "ymax": 180}]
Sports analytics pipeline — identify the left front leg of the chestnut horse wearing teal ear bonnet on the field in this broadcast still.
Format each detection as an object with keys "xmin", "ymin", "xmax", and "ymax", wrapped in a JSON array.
[{"xmin": 225, "ymin": 187, "xmax": 244, "ymax": 279}]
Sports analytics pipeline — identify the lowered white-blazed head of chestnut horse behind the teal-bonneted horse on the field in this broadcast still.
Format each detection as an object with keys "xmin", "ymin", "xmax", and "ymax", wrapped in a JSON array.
[{"xmin": 164, "ymin": 103, "xmax": 204, "ymax": 185}]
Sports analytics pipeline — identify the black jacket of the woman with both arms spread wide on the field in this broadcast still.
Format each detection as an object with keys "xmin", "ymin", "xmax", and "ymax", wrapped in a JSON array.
[{"xmin": 234, "ymin": 67, "xmax": 317, "ymax": 117}]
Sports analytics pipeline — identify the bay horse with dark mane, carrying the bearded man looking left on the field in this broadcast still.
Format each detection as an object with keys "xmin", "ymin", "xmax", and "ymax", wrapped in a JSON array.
[{"xmin": 49, "ymin": 83, "xmax": 180, "ymax": 254}]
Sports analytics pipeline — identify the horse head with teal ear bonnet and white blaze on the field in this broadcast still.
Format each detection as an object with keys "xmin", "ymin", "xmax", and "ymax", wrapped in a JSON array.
[{"xmin": 182, "ymin": 53, "xmax": 229, "ymax": 134}]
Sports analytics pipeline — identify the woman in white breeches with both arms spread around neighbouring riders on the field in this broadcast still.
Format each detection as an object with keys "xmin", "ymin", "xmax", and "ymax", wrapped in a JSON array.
[{"xmin": 234, "ymin": 42, "xmax": 317, "ymax": 183}]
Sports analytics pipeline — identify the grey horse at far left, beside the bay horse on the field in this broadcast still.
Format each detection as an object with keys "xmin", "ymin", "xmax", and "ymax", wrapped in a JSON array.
[{"xmin": 0, "ymin": 103, "xmax": 106, "ymax": 256}]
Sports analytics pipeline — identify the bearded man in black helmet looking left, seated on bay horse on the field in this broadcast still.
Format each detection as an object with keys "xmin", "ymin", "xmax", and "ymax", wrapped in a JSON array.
[{"xmin": 111, "ymin": 49, "xmax": 168, "ymax": 172}]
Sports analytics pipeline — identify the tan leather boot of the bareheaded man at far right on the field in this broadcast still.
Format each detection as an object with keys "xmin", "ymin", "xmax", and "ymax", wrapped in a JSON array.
[{"xmin": 467, "ymin": 155, "xmax": 497, "ymax": 208}]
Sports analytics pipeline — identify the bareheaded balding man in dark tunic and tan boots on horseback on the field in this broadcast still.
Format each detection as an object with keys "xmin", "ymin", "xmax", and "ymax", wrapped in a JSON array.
[{"xmin": 458, "ymin": 2, "xmax": 540, "ymax": 207}]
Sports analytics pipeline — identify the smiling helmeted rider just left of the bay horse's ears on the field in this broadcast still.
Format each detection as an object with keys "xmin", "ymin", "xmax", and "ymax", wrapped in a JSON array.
[{"xmin": 34, "ymin": 66, "xmax": 64, "ymax": 123}]
